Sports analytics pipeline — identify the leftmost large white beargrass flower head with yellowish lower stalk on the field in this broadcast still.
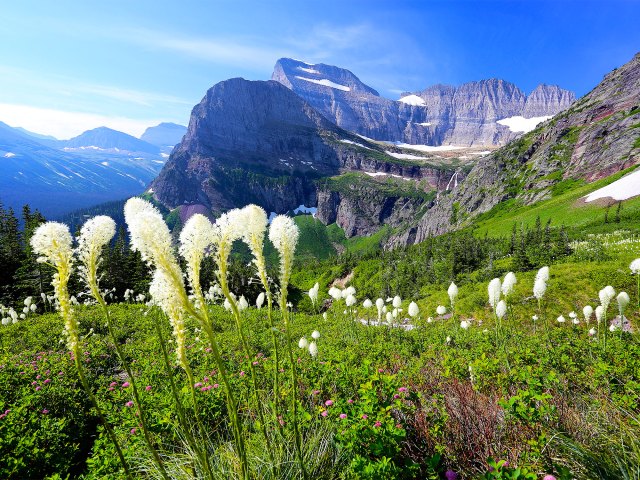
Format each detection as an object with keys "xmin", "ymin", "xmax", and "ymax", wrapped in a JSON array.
[{"xmin": 31, "ymin": 222, "xmax": 79, "ymax": 354}]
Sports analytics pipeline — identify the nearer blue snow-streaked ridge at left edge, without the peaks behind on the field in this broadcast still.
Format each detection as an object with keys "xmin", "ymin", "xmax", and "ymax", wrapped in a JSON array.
[{"xmin": 0, "ymin": 122, "xmax": 164, "ymax": 218}]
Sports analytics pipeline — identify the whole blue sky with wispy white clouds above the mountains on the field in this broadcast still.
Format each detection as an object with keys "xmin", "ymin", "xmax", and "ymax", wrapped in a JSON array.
[{"xmin": 0, "ymin": 0, "xmax": 640, "ymax": 139}]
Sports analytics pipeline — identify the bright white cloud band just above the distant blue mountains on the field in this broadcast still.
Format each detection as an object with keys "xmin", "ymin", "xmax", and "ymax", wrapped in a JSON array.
[{"xmin": 0, "ymin": 103, "xmax": 166, "ymax": 139}]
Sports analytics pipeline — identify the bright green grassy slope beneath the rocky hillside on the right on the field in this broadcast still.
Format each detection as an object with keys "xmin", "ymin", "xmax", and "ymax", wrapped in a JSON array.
[{"xmin": 474, "ymin": 167, "xmax": 640, "ymax": 237}]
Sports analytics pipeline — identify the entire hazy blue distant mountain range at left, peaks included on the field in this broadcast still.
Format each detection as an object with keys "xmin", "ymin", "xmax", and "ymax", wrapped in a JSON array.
[{"xmin": 0, "ymin": 122, "xmax": 184, "ymax": 218}]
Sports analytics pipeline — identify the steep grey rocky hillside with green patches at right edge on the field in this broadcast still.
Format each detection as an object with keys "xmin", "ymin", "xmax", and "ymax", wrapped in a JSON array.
[{"xmin": 393, "ymin": 53, "xmax": 640, "ymax": 244}]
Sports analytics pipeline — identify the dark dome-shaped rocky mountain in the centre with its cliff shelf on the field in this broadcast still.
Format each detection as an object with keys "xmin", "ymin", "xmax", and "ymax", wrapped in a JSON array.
[{"xmin": 152, "ymin": 78, "xmax": 464, "ymax": 235}]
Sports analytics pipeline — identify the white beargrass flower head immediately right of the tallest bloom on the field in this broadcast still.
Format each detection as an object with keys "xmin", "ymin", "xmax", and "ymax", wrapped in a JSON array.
[{"xmin": 179, "ymin": 213, "xmax": 214, "ymax": 308}]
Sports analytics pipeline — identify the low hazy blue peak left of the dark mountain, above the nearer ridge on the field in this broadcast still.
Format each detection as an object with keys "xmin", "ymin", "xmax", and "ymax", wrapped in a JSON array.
[{"xmin": 58, "ymin": 127, "xmax": 160, "ymax": 155}]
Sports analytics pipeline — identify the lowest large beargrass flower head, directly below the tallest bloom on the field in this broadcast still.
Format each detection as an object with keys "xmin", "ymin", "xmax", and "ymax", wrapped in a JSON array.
[{"xmin": 149, "ymin": 269, "xmax": 188, "ymax": 370}]
